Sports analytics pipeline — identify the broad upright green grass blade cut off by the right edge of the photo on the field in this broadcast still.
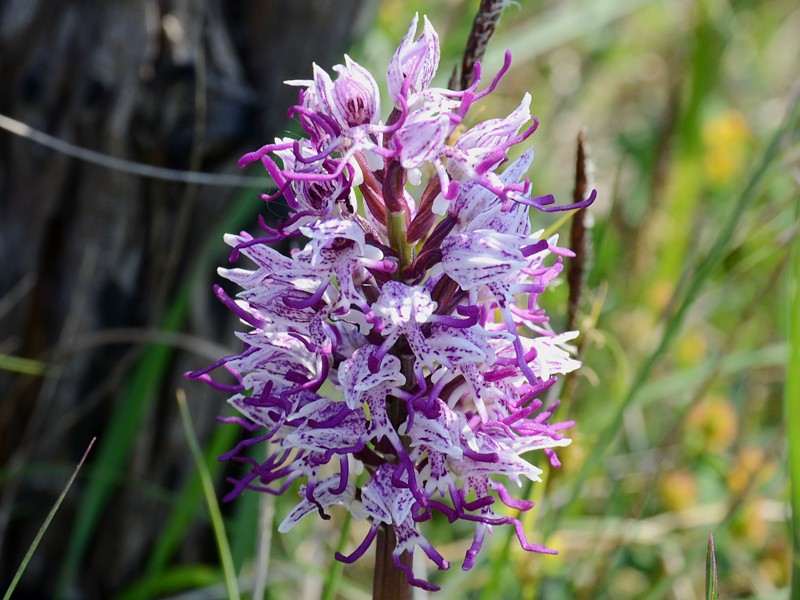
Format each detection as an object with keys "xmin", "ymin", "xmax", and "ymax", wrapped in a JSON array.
[{"xmin": 784, "ymin": 161, "xmax": 800, "ymax": 598}]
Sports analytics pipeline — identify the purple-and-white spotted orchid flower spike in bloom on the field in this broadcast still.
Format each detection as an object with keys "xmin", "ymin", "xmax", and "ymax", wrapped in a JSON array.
[{"xmin": 189, "ymin": 12, "xmax": 591, "ymax": 590}]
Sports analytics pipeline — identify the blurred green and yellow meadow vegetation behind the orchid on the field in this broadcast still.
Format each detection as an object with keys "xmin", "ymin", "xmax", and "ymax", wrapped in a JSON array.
[{"xmin": 1, "ymin": 0, "xmax": 800, "ymax": 600}]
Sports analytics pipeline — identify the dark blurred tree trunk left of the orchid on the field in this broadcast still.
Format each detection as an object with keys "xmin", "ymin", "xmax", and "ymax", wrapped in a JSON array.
[{"xmin": 0, "ymin": 0, "xmax": 374, "ymax": 598}]
